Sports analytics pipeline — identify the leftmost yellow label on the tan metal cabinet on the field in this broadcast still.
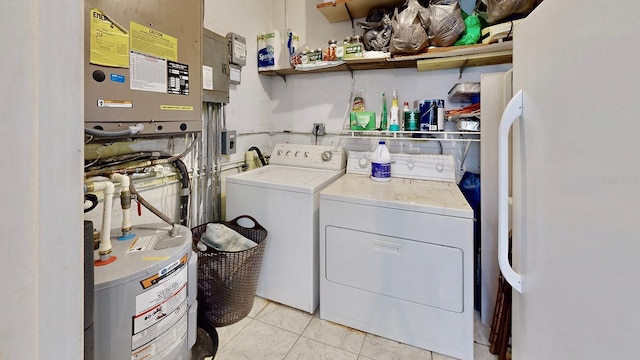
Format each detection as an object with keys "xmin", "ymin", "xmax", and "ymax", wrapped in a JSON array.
[{"xmin": 89, "ymin": 8, "xmax": 129, "ymax": 68}]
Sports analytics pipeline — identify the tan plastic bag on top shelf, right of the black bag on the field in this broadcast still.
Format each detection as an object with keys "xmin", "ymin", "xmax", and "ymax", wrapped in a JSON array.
[{"xmin": 389, "ymin": 0, "xmax": 429, "ymax": 54}]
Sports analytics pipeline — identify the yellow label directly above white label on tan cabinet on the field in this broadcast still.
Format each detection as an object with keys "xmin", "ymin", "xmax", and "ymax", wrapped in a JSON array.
[{"xmin": 129, "ymin": 21, "xmax": 178, "ymax": 61}]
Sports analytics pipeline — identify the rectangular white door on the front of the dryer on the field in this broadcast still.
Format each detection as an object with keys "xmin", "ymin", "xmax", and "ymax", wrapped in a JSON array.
[{"xmin": 325, "ymin": 226, "xmax": 464, "ymax": 313}]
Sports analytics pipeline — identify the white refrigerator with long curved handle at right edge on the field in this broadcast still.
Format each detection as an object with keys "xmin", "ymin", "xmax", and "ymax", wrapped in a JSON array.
[{"xmin": 498, "ymin": 0, "xmax": 640, "ymax": 360}]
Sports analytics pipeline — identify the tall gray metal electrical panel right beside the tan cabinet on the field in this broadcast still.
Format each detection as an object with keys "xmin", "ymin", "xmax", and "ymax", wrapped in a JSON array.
[{"xmin": 202, "ymin": 29, "xmax": 229, "ymax": 104}]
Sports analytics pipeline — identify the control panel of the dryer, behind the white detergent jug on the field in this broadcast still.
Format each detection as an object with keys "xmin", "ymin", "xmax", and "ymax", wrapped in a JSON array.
[{"xmin": 347, "ymin": 151, "xmax": 456, "ymax": 182}]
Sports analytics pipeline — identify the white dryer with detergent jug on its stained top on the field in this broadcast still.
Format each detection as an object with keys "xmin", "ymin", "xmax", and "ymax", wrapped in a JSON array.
[{"xmin": 320, "ymin": 152, "xmax": 474, "ymax": 360}]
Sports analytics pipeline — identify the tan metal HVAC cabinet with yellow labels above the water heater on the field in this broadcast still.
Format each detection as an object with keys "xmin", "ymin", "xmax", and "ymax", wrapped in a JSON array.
[{"xmin": 84, "ymin": 0, "xmax": 203, "ymax": 135}]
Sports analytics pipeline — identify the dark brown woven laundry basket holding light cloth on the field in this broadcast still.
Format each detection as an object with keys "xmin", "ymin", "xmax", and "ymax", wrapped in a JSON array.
[{"xmin": 191, "ymin": 215, "xmax": 267, "ymax": 328}]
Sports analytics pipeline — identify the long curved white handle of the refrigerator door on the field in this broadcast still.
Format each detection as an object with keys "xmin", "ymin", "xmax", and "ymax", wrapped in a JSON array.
[{"xmin": 498, "ymin": 90, "xmax": 522, "ymax": 293}]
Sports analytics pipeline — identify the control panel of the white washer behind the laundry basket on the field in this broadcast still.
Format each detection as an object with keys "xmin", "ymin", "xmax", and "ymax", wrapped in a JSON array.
[{"xmin": 269, "ymin": 144, "xmax": 346, "ymax": 170}]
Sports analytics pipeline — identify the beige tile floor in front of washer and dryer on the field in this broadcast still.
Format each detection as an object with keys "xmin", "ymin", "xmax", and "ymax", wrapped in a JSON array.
[{"xmin": 215, "ymin": 297, "xmax": 497, "ymax": 360}]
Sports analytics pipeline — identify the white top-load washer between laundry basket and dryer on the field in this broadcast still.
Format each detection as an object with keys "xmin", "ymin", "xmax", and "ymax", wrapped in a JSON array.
[{"xmin": 226, "ymin": 144, "xmax": 346, "ymax": 313}]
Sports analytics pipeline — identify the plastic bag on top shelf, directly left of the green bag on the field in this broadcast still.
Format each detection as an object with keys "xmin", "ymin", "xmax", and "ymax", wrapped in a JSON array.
[{"xmin": 428, "ymin": 0, "xmax": 466, "ymax": 46}]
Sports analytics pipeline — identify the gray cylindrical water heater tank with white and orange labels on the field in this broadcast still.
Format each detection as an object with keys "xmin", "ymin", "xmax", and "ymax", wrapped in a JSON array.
[{"xmin": 94, "ymin": 223, "xmax": 197, "ymax": 360}]
